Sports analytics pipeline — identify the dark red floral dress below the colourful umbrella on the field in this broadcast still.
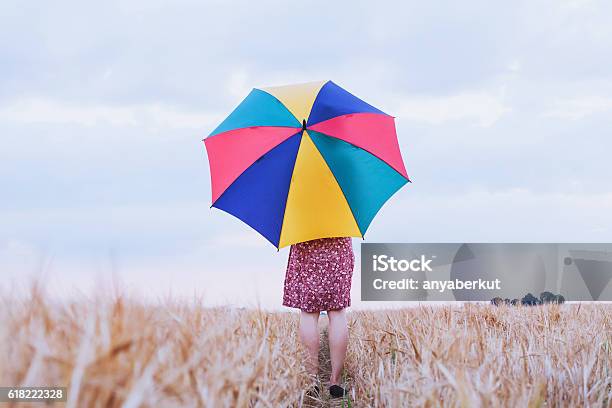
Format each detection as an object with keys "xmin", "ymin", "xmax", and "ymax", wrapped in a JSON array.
[{"xmin": 283, "ymin": 237, "xmax": 355, "ymax": 312}]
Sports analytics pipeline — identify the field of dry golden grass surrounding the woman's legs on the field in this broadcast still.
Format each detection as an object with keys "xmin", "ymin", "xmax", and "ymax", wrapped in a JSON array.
[{"xmin": 0, "ymin": 288, "xmax": 612, "ymax": 407}]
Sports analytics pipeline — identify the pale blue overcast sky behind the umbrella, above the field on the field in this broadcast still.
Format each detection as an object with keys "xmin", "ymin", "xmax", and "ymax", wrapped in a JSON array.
[{"xmin": 0, "ymin": 0, "xmax": 612, "ymax": 307}]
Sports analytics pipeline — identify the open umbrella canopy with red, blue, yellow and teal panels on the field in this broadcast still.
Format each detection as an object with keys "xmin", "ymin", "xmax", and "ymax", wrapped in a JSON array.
[{"xmin": 204, "ymin": 81, "xmax": 410, "ymax": 248}]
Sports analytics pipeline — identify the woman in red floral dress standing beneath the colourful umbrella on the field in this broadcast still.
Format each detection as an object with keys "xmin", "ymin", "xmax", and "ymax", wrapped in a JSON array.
[{"xmin": 283, "ymin": 237, "xmax": 355, "ymax": 398}]
